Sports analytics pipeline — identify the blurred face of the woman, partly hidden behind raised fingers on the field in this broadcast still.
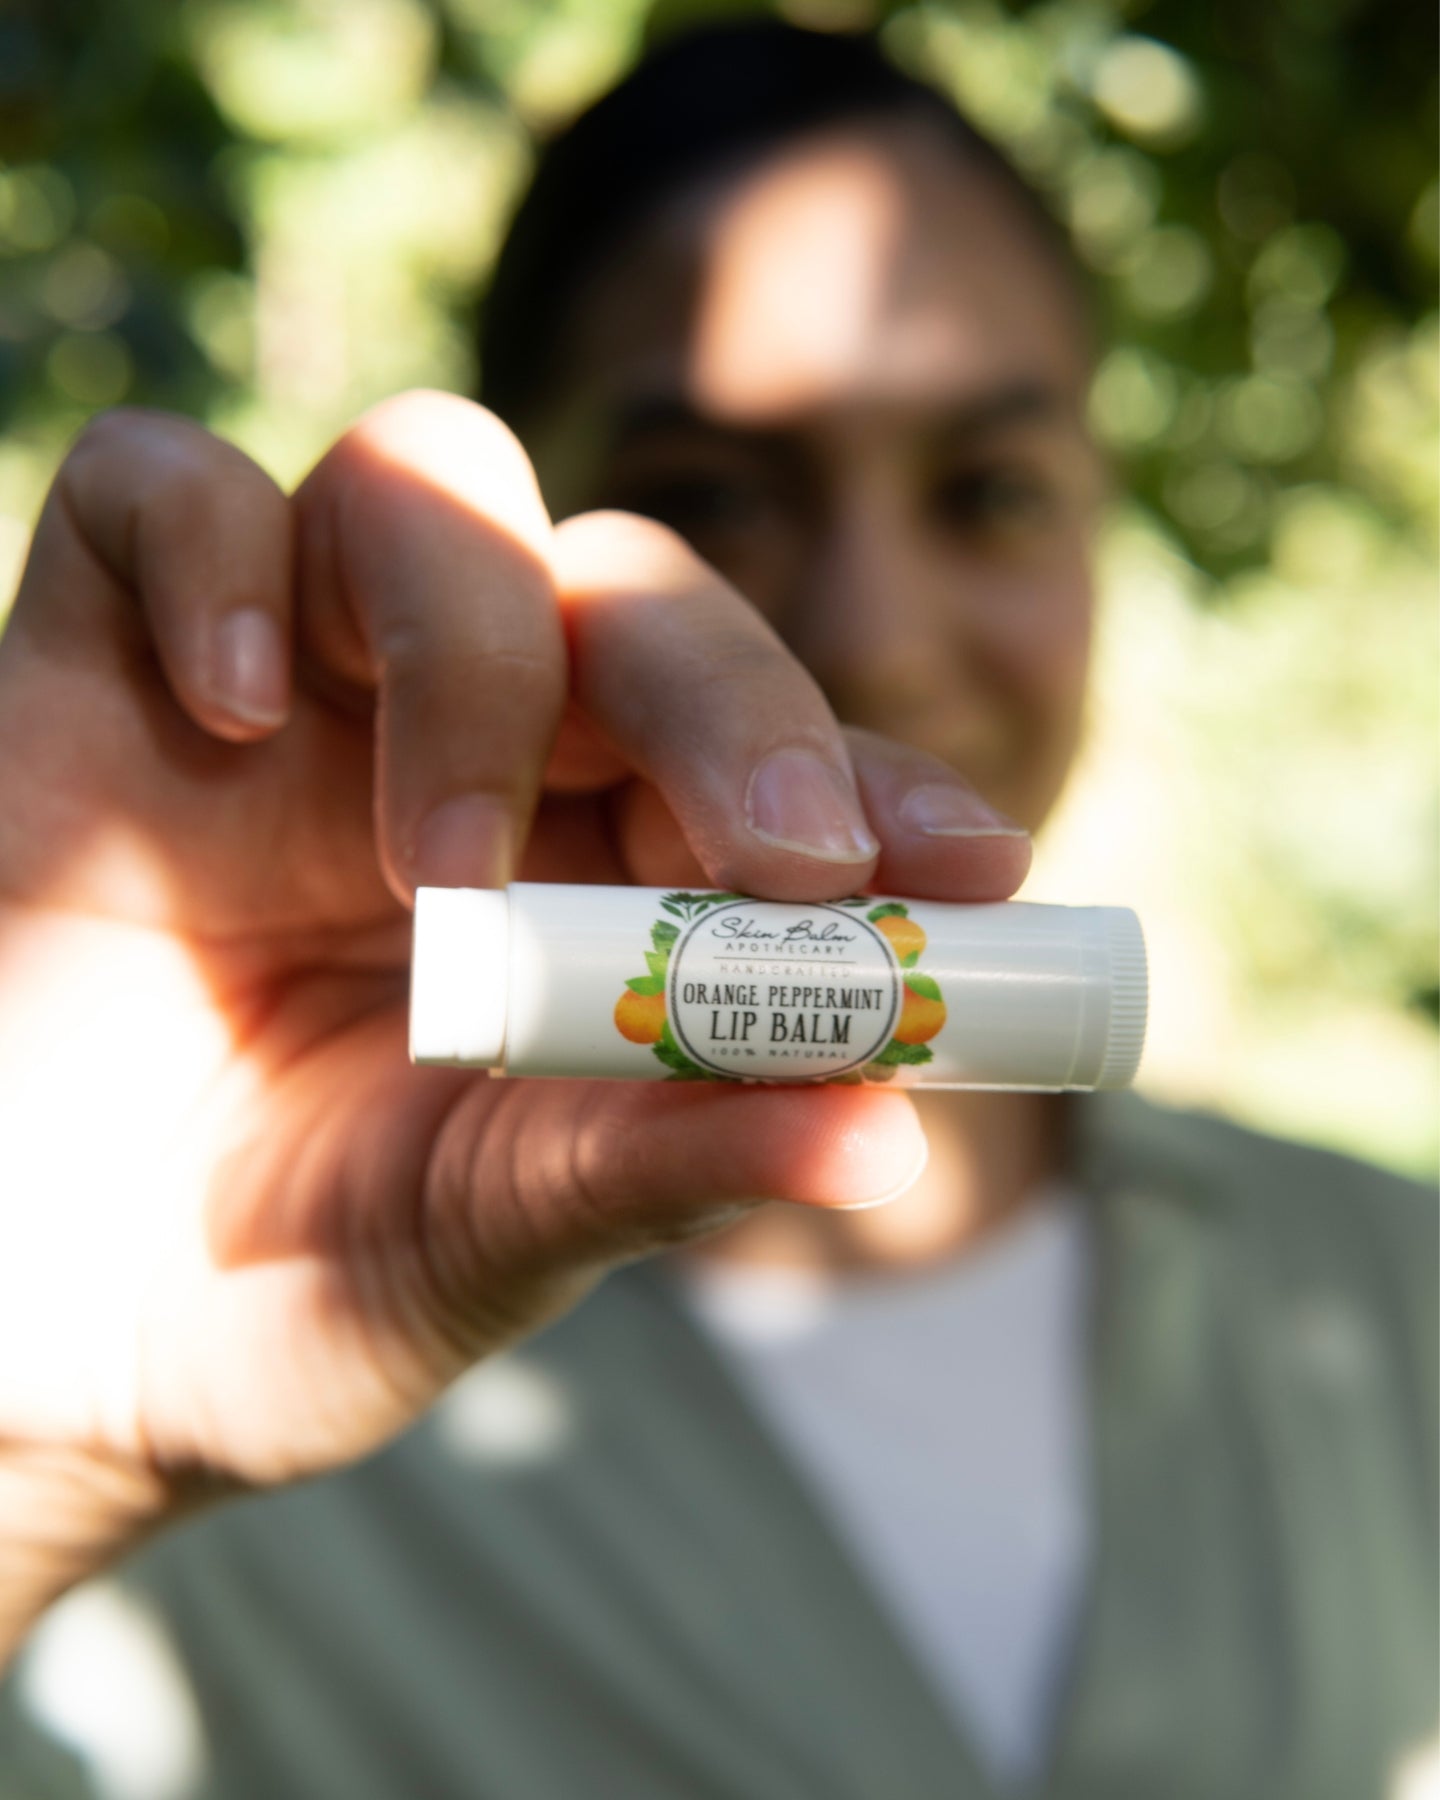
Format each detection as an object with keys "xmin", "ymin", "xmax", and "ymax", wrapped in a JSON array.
[{"xmin": 529, "ymin": 122, "xmax": 1102, "ymax": 828}]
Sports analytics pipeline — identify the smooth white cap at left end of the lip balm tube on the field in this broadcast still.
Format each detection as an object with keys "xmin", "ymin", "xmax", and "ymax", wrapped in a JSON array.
[{"xmin": 410, "ymin": 887, "xmax": 509, "ymax": 1069}]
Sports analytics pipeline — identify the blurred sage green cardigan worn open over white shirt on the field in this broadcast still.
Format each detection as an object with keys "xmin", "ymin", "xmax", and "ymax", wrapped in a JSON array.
[{"xmin": 0, "ymin": 1094, "xmax": 1440, "ymax": 1800}]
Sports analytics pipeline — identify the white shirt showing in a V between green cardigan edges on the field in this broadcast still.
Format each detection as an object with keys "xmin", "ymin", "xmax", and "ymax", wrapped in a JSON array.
[{"xmin": 682, "ymin": 1188, "xmax": 1091, "ymax": 1780}]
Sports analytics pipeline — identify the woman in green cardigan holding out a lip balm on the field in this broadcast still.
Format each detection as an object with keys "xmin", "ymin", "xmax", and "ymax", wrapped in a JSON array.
[{"xmin": 0, "ymin": 17, "xmax": 1435, "ymax": 1800}]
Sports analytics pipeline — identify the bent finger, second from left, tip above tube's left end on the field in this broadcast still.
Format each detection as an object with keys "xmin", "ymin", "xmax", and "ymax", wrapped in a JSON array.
[{"xmin": 295, "ymin": 392, "xmax": 565, "ymax": 900}]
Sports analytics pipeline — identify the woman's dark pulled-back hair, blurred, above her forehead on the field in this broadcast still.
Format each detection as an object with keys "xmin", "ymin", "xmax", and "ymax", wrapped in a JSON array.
[{"xmin": 481, "ymin": 20, "xmax": 1080, "ymax": 423}]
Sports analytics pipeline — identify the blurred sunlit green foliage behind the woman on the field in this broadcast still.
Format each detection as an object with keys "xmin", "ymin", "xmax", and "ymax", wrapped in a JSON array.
[{"xmin": 0, "ymin": 0, "xmax": 1440, "ymax": 1172}]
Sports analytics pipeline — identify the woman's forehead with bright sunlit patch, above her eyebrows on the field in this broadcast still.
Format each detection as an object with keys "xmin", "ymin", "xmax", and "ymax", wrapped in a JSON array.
[{"xmin": 576, "ymin": 122, "xmax": 1087, "ymax": 425}]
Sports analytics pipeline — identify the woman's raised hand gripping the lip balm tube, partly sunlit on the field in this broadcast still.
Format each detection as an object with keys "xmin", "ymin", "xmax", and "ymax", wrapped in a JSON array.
[{"xmin": 0, "ymin": 394, "xmax": 1030, "ymax": 1647}]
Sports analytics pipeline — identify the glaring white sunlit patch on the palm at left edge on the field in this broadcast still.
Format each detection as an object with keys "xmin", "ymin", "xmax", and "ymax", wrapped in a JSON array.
[{"xmin": 0, "ymin": 878, "xmax": 247, "ymax": 1444}]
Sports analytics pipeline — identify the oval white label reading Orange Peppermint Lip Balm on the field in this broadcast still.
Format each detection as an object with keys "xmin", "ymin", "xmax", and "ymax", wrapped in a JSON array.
[{"xmin": 666, "ymin": 900, "xmax": 902, "ymax": 1082}]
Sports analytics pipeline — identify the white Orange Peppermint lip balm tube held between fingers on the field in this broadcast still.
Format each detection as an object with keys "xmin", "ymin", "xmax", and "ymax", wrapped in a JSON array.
[{"xmin": 410, "ymin": 882, "xmax": 1147, "ymax": 1093}]
